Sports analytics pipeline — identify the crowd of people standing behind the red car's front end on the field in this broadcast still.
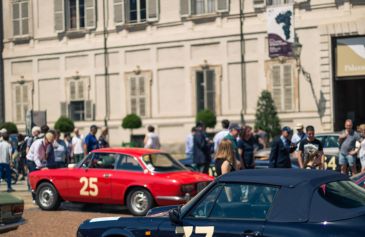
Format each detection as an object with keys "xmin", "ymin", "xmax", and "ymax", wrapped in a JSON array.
[{"xmin": 0, "ymin": 125, "xmax": 109, "ymax": 192}]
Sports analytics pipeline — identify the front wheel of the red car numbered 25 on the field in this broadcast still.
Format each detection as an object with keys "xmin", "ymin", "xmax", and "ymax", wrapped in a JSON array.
[{"xmin": 36, "ymin": 183, "xmax": 61, "ymax": 211}]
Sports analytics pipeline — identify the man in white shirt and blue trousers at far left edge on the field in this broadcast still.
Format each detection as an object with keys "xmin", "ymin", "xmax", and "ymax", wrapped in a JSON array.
[{"xmin": 0, "ymin": 131, "xmax": 15, "ymax": 192}]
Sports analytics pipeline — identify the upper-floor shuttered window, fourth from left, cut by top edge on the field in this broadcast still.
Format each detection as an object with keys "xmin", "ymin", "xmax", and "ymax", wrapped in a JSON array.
[{"xmin": 180, "ymin": 0, "xmax": 229, "ymax": 17}]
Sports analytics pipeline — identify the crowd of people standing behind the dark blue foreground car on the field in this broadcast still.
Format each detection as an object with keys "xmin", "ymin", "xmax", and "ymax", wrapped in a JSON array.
[{"xmin": 185, "ymin": 119, "xmax": 365, "ymax": 176}]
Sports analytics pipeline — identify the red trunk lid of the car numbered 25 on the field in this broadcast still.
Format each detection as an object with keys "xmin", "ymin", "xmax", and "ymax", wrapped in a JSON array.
[{"xmin": 155, "ymin": 171, "xmax": 210, "ymax": 183}]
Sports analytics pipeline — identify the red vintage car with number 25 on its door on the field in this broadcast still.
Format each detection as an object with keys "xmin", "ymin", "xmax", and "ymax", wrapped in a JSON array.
[{"xmin": 29, "ymin": 148, "xmax": 213, "ymax": 215}]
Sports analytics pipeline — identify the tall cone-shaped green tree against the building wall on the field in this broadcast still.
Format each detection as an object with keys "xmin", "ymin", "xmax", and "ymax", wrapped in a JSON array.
[{"xmin": 255, "ymin": 90, "xmax": 281, "ymax": 138}]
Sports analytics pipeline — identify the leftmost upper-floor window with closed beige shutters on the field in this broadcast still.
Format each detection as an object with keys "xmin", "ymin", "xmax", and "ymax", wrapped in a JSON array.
[{"xmin": 10, "ymin": 0, "xmax": 32, "ymax": 39}]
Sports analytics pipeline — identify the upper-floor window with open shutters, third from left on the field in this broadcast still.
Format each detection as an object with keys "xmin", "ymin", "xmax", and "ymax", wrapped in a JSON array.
[{"xmin": 114, "ymin": 0, "xmax": 159, "ymax": 25}]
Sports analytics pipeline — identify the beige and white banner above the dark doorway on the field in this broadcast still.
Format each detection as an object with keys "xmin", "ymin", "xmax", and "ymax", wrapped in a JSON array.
[{"xmin": 336, "ymin": 37, "xmax": 365, "ymax": 77}]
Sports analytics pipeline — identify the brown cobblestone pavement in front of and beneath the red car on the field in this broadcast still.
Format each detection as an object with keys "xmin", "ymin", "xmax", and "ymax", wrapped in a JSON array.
[{"xmin": 0, "ymin": 181, "xmax": 130, "ymax": 237}]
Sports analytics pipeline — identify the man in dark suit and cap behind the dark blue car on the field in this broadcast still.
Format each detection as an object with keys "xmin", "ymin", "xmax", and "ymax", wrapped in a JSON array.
[{"xmin": 269, "ymin": 126, "xmax": 296, "ymax": 168}]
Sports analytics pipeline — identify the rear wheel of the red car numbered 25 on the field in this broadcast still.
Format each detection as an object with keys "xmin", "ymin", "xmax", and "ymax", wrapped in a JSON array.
[{"xmin": 127, "ymin": 188, "xmax": 153, "ymax": 216}]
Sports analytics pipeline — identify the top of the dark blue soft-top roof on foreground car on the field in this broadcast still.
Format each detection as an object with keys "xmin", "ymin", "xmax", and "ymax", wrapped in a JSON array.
[{"xmin": 219, "ymin": 169, "xmax": 348, "ymax": 188}]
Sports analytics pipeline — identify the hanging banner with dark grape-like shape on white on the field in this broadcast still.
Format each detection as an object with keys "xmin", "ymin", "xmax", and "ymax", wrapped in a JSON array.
[{"xmin": 267, "ymin": 5, "xmax": 294, "ymax": 58}]
